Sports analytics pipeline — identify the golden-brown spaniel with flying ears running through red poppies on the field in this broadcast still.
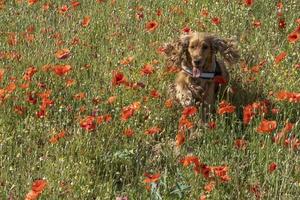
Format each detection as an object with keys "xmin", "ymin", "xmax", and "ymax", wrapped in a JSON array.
[{"xmin": 164, "ymin": 32, "xmax": 240, "ymax": 118}]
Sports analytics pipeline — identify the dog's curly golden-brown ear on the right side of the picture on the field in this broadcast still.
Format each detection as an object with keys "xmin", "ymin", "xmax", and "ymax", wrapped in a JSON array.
[{"xmin": 211, "ymin": 36, "xmax": 240, "ymax": 65}]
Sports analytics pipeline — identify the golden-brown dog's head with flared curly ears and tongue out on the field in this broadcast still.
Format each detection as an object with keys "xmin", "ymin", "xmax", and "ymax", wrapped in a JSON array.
[{"xmin": 166, "ymin": 32, "xmax": 239, "ymax": 76}]
